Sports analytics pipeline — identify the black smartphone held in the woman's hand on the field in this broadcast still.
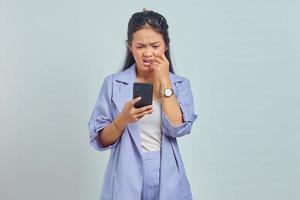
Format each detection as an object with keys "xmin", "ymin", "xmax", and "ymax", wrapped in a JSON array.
[{"xmin": 133, "ymin": 82, "xmax": 153, "ymax": 108}]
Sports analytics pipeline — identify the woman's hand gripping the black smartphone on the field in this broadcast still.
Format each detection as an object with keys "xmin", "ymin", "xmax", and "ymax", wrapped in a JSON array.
[{"xmin": 119, "ymin": 97, "xmax": 153, "ymax": 126}]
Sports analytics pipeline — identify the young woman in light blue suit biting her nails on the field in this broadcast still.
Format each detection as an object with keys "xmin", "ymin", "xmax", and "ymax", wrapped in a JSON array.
[{"xmin": 89, "ymin": 9, "xmax": 197, "ymax": 200}]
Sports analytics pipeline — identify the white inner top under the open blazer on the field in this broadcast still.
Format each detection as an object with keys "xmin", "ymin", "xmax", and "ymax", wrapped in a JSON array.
[{"xmin": 138, "ymin": 99, "xmax": 161, "ymax": 152}]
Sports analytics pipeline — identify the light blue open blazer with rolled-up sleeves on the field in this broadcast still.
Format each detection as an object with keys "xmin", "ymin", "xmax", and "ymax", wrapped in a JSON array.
[{"xmin": 88, "ymin": 64, "xmax": 197, "ymax": 200}]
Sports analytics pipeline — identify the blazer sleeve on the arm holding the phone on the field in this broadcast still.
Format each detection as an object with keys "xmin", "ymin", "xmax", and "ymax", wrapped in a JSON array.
[{"xmin": 88, "ymin": 75, "xmax": 118, "ymax": 151}]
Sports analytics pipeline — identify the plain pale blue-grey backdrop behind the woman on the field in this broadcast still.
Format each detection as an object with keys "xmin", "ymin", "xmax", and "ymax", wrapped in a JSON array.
[{"xmin": 0, "ymin": 0, "xmax": 300, "ymax": 200}]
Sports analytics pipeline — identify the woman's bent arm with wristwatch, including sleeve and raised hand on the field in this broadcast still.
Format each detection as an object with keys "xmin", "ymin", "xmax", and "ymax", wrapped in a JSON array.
[{"xmin": 152, "ymin": 54, "xmax": 197, "ymax": 137}]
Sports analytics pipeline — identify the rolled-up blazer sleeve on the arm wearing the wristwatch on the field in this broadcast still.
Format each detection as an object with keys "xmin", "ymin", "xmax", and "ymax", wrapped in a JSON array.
[{"xmin": 161, "ymin": 78, "xmax": 197, "ymax": 138}]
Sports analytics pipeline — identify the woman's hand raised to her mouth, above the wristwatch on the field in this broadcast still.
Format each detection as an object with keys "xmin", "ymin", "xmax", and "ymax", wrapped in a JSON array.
[{"xmin": 151, "ymin": 53, "xmax": 171, "ymax": 85}]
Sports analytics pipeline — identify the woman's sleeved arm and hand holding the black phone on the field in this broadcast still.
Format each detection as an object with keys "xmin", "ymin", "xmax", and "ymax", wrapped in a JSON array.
[{"xmin": 88, "ymin": 76, "xmax": 153, "ymax": 151}]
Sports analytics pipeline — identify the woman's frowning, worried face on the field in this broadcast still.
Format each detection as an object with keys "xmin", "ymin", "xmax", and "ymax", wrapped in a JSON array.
[{"xmin": 129, "ymin": 24, "xmax": 167, "ymax": 72}]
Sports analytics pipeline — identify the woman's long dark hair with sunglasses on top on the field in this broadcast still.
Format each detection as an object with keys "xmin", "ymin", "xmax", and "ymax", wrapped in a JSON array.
[{"xmin": 121, "ymin": 9, "xmax": 174, "ymax": 73}]
